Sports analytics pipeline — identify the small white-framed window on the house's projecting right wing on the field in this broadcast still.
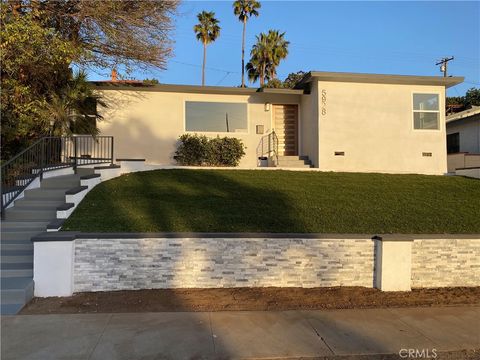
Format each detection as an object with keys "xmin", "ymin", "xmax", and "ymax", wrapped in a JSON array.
[{"xmin": 413, "ymin": 94, "xmax": 440, "ymax": 130}]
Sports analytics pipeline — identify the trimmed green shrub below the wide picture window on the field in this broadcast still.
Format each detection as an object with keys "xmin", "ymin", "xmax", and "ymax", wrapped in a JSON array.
[{"xmin": 173, "ymin": 134, "xmax": 245, "ymax": 166}]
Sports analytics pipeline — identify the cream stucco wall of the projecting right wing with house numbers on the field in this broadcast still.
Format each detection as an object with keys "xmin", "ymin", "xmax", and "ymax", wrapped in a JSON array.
[{"xmin": 317, "ymin": 81, "xmax": 447, "ymax": 175}]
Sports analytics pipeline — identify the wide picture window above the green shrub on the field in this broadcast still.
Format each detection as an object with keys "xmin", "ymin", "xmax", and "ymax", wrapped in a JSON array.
[{"xmin": 185, "ymin": 101, "xmax": 248, "ymax": 132}]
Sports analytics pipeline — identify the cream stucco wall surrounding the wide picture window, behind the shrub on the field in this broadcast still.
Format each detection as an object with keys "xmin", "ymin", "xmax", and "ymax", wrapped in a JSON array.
[{"xmin": 98, "ymin": 90, "xmax": 300, "ymax": 167}]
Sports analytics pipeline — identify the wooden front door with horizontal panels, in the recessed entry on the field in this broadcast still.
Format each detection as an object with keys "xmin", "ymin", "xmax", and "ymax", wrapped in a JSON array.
[{"xmin": 273, "ymin": 105, "xmax": 298, "ymax": 156}]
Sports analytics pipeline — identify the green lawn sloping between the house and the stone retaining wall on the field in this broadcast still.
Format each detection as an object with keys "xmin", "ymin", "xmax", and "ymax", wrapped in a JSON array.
[{"xmin": 63, "ymin": 170, "xmax": 480, "ymax": 234}]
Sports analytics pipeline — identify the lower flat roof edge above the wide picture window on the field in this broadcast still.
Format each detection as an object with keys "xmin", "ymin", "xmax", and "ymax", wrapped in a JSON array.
[{"xmin": 91, "ymin": 81, "xmax": 304, "ymax": 95}]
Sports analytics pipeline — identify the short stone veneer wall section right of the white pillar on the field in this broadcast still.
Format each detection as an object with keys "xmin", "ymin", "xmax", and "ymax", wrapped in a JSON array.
[{"xmin": 412, "ymin": 239, "xmax": 480, "ymax": 288}]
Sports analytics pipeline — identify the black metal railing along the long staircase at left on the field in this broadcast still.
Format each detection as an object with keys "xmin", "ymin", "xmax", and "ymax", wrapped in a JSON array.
[{"xmin": 0, "ymin": 135, "xmax": 114, "ymax": 216}]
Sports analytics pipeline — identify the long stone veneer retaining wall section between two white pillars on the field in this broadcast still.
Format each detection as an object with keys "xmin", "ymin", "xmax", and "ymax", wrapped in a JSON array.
[{"xmin": 74, "ymin": 238, "xmax": 374, "ymax": 292}]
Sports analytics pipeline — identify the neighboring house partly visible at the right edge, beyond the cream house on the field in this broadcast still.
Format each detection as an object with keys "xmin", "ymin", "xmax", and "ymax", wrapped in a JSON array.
[{"xmin": 446, "ymin": 106, "xmax": 480, "ymax": 172}]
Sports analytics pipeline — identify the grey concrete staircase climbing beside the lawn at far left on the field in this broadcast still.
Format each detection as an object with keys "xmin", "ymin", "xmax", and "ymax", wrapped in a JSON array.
[{"xmin": 0, "ymin": 169, "xmax": 94, "ymax": 314}]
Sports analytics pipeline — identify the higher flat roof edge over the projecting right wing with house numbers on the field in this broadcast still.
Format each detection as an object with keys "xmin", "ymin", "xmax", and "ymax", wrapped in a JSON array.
[{"xmin": 295, "ymin": 71, "xmax": 465, "ymax": 88}]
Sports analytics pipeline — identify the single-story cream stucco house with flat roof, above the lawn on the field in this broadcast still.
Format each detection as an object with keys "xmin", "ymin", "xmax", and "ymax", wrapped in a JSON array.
[{"xmin": 94, "ymin": 72, "xmax": 463, "ymax": 174}]
